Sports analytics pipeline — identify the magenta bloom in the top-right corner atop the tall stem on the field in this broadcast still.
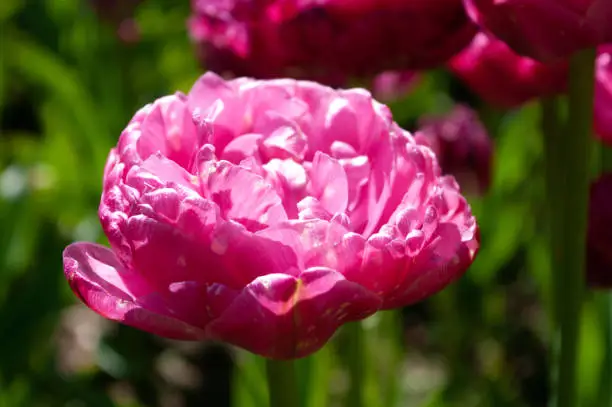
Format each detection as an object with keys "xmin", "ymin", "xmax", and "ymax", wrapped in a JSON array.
[{"xmin": 464, "ymin": 0, "xmax": 612, "ymax": 62}]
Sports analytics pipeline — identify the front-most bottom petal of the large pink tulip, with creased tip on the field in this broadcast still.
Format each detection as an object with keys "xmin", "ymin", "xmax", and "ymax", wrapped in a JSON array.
[{"xmin": 207, "ymin": 267, "xmax": 380, "ymax": 359}]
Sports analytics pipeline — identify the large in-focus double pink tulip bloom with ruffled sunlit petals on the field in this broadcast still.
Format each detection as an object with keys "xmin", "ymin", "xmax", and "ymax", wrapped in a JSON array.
[{"xmin": 64, "ymin": 73, "xmax": 478, "ymax": 358}]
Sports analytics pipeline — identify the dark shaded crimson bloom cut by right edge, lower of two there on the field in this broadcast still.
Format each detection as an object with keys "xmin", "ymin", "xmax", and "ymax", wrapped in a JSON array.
[{"xmin": 586, "ymin": 174, "xmax": 612, "ymax": 289}]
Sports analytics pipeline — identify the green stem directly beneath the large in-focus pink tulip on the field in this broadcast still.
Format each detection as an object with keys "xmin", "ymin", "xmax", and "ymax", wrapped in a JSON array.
[{"xmin": 266, "ymin": 359, "xmax": 300, "ymax": 407}]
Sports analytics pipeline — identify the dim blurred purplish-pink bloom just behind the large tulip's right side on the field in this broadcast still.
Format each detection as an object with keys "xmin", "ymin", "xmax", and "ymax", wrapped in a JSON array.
[{"xmin": 415, "ymin": 106, "xmax": 493, "ymax": 195}]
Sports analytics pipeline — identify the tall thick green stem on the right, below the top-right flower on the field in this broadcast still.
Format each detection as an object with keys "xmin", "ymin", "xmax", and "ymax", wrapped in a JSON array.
[{"xmin": 553, "ymin": 50, "xmax": 595, "ymax": 407}]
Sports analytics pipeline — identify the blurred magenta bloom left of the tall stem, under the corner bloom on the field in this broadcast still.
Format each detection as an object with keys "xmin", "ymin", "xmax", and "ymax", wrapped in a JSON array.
[{"xmin": 449, "ymin": 33, "xmax": 568, "ymax": 108}]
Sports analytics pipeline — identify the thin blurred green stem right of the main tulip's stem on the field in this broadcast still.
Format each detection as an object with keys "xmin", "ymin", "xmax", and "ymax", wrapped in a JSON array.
[{"xmin": 344, "ymin": 321, "xmax": 365, "ymax": 407}]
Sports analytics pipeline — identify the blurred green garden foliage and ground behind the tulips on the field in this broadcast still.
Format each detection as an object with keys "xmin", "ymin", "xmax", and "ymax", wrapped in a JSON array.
[{"xmin": 0, "ymin": 0, "xmax": 612, "ymax": 407}]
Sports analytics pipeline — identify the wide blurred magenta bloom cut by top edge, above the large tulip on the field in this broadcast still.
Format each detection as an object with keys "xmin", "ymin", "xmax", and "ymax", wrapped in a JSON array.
[{"xmin": 188, "ymin": 0, "xmax": 476, "ymax": 86}]
